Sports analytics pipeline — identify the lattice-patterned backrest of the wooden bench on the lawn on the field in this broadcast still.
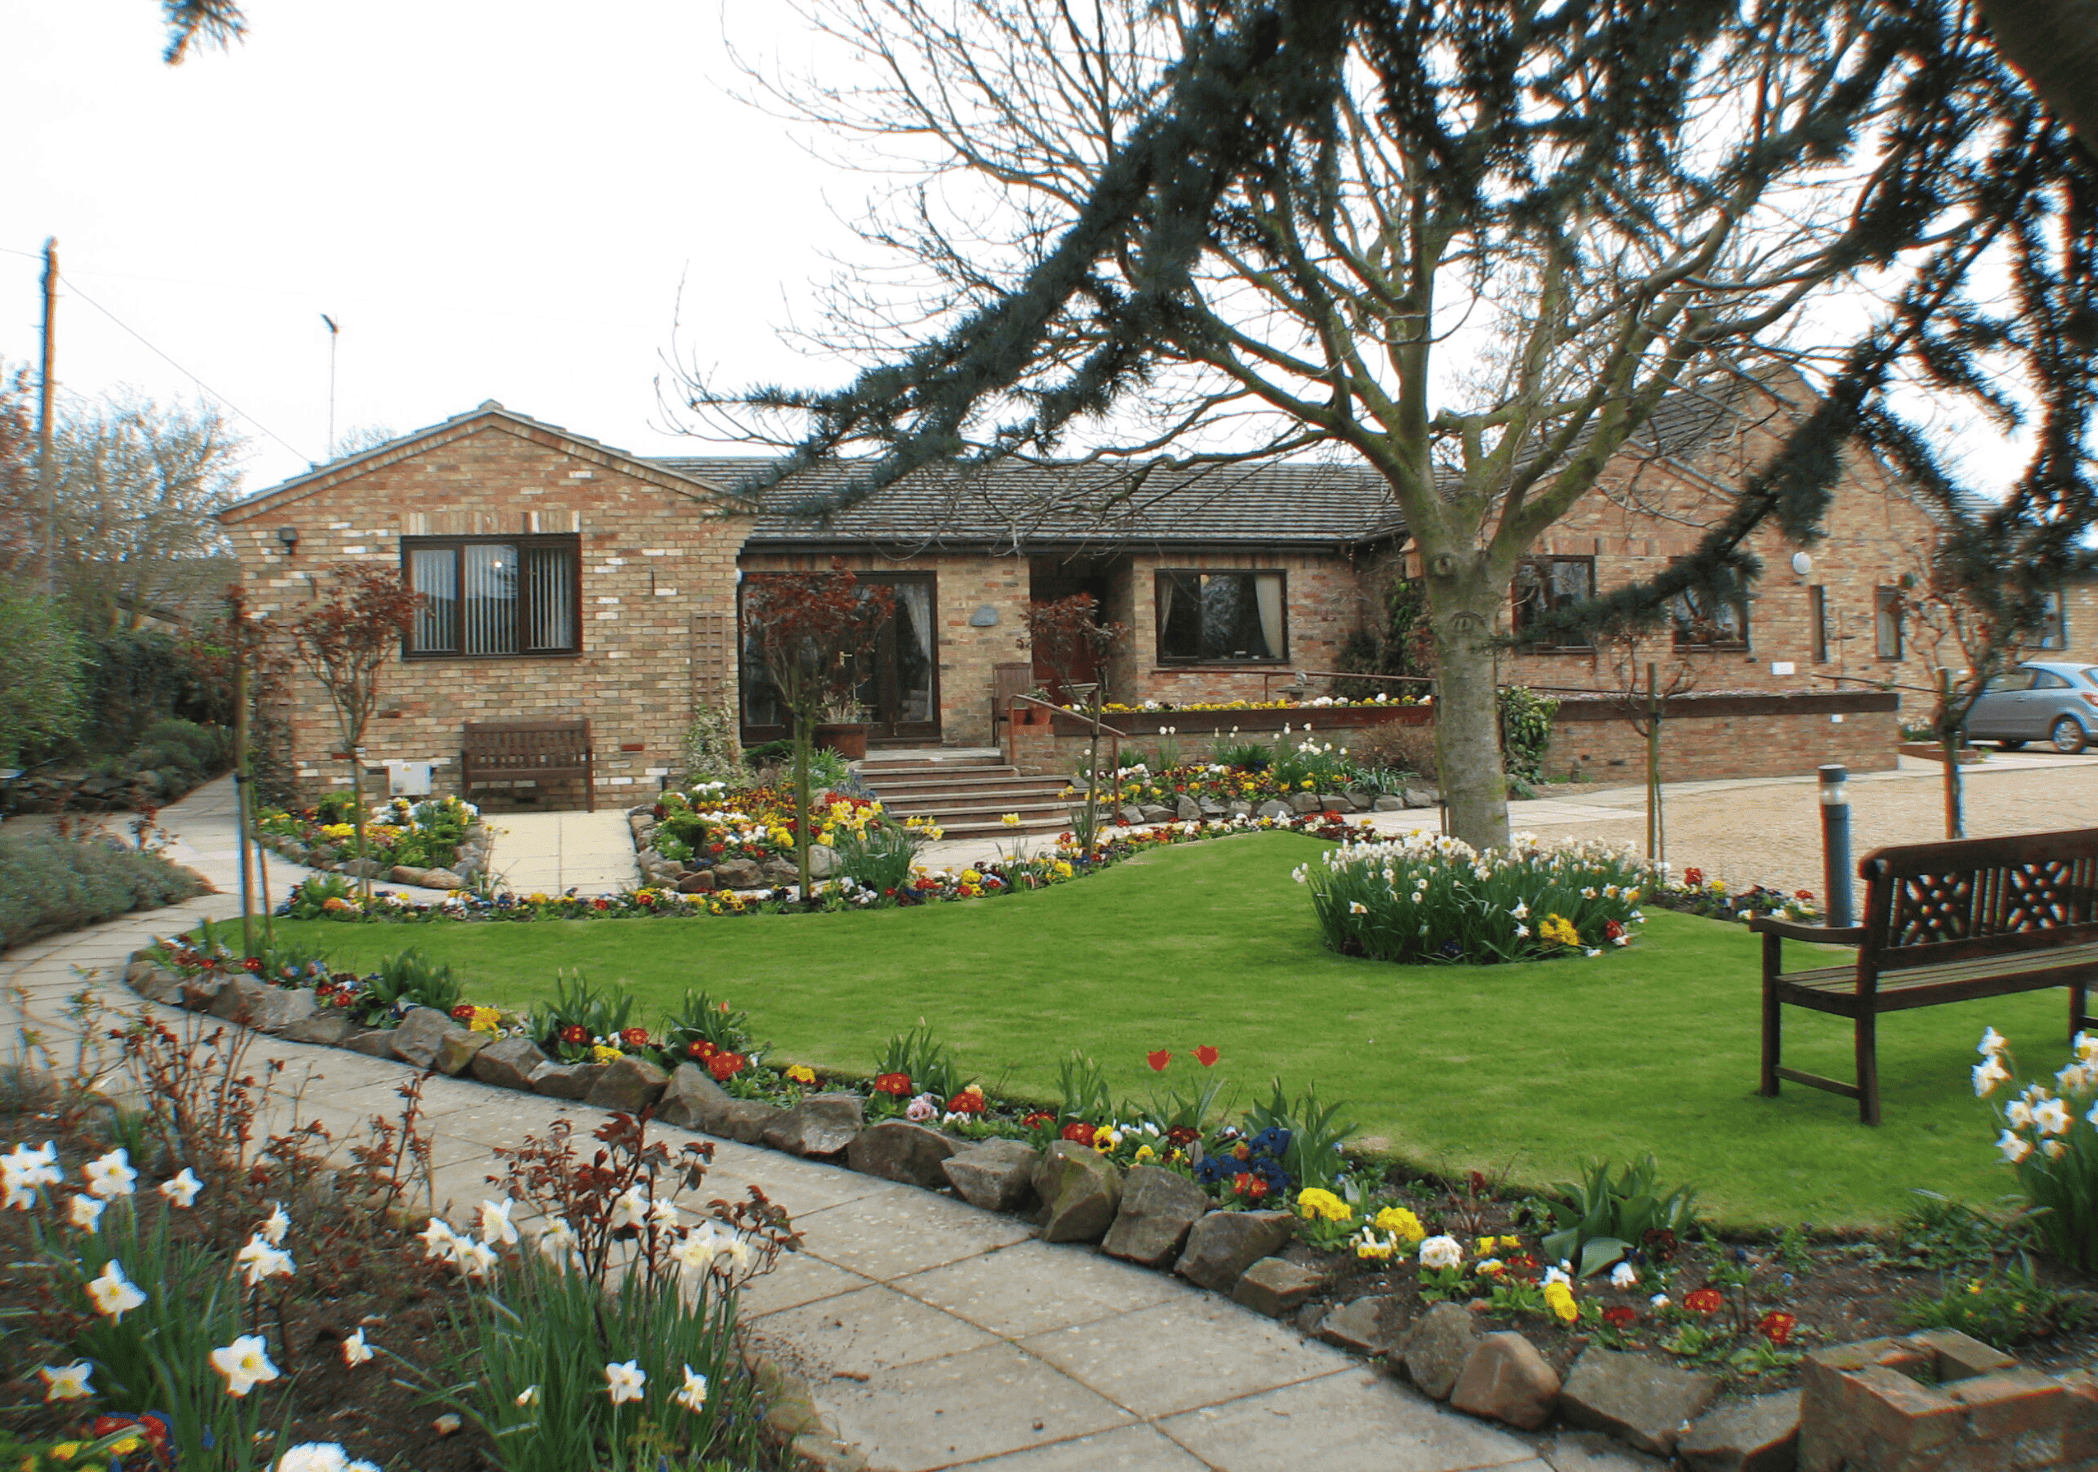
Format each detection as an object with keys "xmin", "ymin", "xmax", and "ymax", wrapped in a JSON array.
[{"xmin": 1857, "ymin": 828, "xmax": 2098, "ymax": 971}]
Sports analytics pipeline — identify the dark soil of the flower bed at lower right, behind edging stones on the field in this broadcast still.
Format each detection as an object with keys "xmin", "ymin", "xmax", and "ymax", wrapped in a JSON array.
[{"xmin": 1282, "ymin": 1174, "xmax": 2098, "ymax": 1394}]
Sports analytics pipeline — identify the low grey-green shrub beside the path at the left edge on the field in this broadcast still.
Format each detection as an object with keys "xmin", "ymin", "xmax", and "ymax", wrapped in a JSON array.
[{"xmin": 0, "ymin": 830, "xmax": 204, "ymax": 950}]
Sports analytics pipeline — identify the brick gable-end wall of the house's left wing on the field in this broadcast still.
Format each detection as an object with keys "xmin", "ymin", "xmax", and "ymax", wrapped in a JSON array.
[{"xmin": 222, "ymin": 411, "xmax": 745, "ymax": 805}]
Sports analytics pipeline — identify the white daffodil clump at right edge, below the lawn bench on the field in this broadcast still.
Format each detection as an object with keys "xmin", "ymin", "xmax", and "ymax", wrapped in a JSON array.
[{"xmin": 1974, "ymin": 1027, "xmax": 2098, "ymax": 1271}]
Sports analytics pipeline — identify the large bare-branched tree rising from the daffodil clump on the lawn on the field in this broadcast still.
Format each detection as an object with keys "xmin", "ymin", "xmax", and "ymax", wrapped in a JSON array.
[{"xmin": 690, "ymin": 0, "xmax": 2089, "ymax": 845}]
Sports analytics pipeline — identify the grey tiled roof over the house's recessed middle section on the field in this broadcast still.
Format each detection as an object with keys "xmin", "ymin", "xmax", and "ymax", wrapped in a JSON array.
[{"xmin": 655, "ymin": 457, "xmax": 1404, "ymax": 549}]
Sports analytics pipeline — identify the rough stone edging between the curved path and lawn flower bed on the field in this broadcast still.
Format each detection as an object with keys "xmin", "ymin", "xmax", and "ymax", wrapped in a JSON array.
[{"xmin": 124, "ymin": 950, "xmax": 2098, "ymax": 1472}]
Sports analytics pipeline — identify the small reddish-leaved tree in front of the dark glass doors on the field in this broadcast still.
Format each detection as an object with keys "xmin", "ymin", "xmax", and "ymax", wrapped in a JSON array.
[{"xmin": 743, "ymin": 558, "xmax": 896, "ymax": 904}]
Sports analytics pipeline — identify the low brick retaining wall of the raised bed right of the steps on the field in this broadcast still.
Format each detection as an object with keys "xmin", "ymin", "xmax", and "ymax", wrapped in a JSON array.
[{"xmin": 1007, "ymin": 690, "xmax": 1901, "ymax": 782}]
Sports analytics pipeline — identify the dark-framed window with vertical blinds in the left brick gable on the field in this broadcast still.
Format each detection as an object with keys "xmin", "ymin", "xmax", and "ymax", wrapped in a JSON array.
[{"xmin": 401, "ymin": 537, "xmax": 581, "ymax": 658}]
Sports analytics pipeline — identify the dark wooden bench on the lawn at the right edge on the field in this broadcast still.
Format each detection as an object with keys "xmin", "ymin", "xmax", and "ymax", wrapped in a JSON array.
[{"xmin": 1750, "ymin": 828, "xmax": 2098, "ymax": 1124}]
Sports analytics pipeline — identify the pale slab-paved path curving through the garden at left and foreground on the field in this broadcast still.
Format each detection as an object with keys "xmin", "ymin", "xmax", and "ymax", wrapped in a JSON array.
[{"xmin": 0, "ymin": 791, "xmax": 1586, "ymax": 1472}]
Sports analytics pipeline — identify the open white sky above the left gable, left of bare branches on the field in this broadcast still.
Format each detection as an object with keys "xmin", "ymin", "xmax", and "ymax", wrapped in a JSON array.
[{"xmin": 0, "ymin": 0, "xmax": 866, "ymax": 489}]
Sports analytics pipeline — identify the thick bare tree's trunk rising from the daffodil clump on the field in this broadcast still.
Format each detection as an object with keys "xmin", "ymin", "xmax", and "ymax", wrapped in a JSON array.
[{"xmin": 1425, "ymin": 551, "xmax": 1508, "ymax": 849}]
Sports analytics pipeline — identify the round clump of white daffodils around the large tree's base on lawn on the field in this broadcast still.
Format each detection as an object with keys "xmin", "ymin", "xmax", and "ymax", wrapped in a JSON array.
[{"xmin": 1294, "ymin": 832, "xmax": 1653, "ymax": 965}]
